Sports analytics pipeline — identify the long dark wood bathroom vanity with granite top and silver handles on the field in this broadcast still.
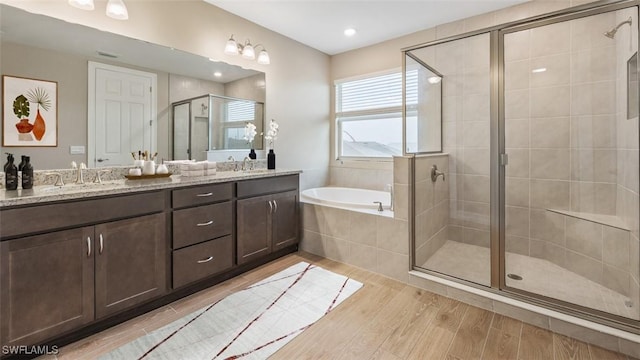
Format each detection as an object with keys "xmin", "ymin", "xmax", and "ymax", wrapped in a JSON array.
[{"xmin": 0, "ymin": 170, "xmax": 299, "ymax": 352}]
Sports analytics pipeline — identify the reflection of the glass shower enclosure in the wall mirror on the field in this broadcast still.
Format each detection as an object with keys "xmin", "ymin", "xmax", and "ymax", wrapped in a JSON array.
[{"xmin": 172, "ymin": 94, "xmax": 264, "ymax": 161}]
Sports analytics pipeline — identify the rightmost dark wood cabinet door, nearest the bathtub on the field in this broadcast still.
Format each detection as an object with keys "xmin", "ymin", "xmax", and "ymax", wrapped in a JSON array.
[{"xmin": 271, "ymin": 191, "xmax": 298, "ymax": 251}]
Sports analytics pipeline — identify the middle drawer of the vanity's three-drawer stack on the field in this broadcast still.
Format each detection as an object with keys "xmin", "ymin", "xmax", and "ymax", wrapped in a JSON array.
[{"xmin": 173, "ymin": 201, "xmax": 233, "ymax": 249}]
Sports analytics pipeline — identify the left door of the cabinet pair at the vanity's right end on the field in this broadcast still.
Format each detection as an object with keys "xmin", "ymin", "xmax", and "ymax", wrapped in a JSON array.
[{"xmin": 237, "ymin": 195, "xmax": 273, "ymax": 264}]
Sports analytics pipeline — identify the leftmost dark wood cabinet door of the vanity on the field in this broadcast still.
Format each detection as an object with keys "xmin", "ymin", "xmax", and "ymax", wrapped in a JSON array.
[{"xmin": 0, "ymin": 227, "xmax": 94, "ymax": 346}]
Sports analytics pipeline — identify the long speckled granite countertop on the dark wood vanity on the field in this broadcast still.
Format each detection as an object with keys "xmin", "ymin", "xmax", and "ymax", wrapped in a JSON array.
[{"xmin": 0, "ymin": 169, "xmax": 302, "ymax": 208}]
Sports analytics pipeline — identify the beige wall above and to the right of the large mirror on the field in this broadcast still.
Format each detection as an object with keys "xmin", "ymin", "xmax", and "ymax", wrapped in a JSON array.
[{"xmin": 1, "ymin": 0, "xmax": 330, "ymax": 188}]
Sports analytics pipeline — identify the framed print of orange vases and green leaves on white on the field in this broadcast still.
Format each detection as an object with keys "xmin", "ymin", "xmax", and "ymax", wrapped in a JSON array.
[{"xmin": 2, "ymin": 75, "xmax": 58, "ymax": 146}]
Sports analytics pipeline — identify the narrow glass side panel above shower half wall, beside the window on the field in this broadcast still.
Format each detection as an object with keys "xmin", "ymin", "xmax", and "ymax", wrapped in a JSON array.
[{"xmin": 404, "ymin": 50, "xmax": 443, "ymax": 153}]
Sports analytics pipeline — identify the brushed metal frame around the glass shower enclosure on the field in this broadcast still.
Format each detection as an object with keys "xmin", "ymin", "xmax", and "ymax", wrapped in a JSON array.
[{"xmin": 401, "ymin": 0, "xmax": 640, "ymax": 334}]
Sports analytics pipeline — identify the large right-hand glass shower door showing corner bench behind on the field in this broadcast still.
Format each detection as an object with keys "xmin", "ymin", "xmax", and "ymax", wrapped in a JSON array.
[{"xmin": 501, "ymin": 7, "xmax": 640, "ymax": 319}]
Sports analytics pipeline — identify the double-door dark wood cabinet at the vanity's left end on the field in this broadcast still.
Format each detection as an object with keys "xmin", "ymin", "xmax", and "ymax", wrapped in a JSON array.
[{"xmin": 0, "ymin": 194, "xmax": 168, "ymax": 345}]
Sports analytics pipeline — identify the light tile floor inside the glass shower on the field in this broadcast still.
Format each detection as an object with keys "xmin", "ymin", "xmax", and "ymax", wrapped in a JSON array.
[{"xmin": 422, "ymin": 240, "xmax": 639, "ymax": 319}]
